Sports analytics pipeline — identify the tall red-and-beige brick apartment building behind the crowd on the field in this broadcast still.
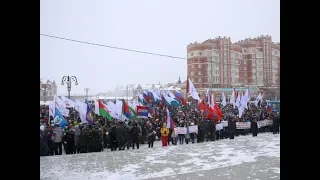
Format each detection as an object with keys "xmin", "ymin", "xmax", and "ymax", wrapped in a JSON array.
[{"xmin": 187, "ymin": 36, "xmax": 280, "ymax": 97}]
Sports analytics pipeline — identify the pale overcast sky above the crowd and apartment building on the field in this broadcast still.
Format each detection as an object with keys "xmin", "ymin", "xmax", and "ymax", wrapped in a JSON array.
[{"xmin": 40, "ymin": 0, "xmax": 280, "ymax": 95}]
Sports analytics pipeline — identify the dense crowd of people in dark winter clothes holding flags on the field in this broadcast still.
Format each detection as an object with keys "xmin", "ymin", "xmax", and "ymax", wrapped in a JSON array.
[{"xmin": 40, "ymin": 100, "xmax": 280, "ymax": 156}]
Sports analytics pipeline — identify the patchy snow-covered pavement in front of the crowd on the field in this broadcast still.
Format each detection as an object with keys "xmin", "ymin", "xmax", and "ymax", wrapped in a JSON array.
[{"xmin": 40, "ymin": 133, "xmax": 280, "ymax": 180}]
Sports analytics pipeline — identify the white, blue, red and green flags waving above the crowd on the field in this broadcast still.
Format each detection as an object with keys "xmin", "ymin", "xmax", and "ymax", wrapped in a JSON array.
[{"xmin": 49, "ymin": 77, "xmax": 263, "ymax": 129}]
